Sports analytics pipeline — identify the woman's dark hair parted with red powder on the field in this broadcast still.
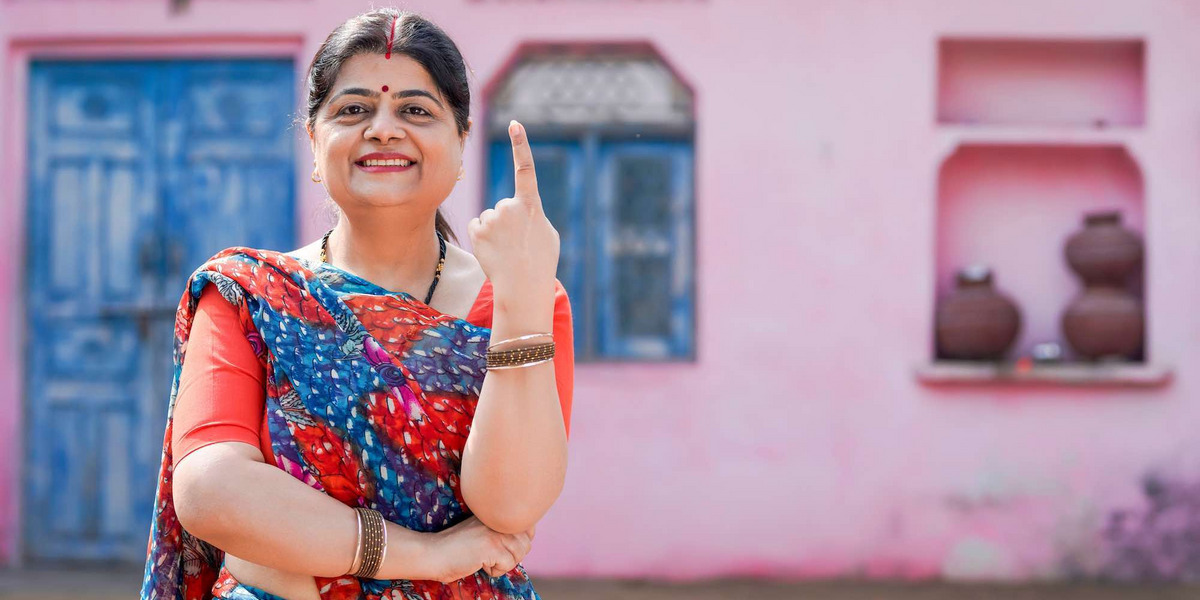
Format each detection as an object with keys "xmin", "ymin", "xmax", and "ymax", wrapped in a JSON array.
[{"xmin": 305, "ymin": 8, "xmax": 470, "ymax": 241}]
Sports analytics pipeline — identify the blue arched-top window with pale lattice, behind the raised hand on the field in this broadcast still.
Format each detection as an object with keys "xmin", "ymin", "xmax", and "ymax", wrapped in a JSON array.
[{"xmin": 485, "ymin": 47, "xmax": 695, "ymax": 360}]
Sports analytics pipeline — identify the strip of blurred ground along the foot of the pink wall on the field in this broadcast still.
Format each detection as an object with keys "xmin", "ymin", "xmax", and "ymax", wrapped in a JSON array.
[{"xmin": 0, "ymin": 569, "xmax": 1200, "ymax": 600}]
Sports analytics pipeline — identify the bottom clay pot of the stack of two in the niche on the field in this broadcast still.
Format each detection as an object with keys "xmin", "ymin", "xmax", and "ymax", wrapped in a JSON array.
[{"xmin": 1062, "ymin": 286, "xmax": 1145, "ymax": 359}]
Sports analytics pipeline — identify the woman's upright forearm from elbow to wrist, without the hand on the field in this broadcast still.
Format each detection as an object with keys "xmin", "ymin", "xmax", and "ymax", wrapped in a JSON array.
[{"xmin": 461, "ymin": 286, "xmax": 566, "ymax": 533}]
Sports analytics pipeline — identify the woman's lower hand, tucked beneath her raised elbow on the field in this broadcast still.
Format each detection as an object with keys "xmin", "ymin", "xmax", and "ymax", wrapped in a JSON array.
[{"xmin": 430, "ymin": 516, "xmax": 534, "ymax": 583}]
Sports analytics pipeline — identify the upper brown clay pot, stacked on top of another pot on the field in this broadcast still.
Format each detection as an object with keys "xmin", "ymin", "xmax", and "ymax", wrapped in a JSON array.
[{"xmin": 1066, "ymin": 210, "xmax": 1142, "ymax": 286}]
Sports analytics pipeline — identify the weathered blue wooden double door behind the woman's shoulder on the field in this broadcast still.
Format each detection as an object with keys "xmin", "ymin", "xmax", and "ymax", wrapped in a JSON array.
[{"xmin": 23, "ymin": 60, "xmax": 295, "ymax": 563}]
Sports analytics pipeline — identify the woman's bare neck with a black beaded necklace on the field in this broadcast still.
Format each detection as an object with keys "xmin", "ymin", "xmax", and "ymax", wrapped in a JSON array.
[{"xmin": 326, "ymin": 212, "xmax": 439, "ymax": 300}]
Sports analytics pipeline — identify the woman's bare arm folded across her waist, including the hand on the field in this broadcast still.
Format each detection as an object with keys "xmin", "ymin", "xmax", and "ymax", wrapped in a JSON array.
[{"xmin": 174, "ymin": 442, "xmax": 534, "ymax": 583}]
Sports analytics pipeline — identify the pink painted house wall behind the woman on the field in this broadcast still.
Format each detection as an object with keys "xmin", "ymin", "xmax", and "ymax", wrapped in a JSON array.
[{"xmin": 7, "ymin": 0, "xmax": 1200, "ymax": 578}]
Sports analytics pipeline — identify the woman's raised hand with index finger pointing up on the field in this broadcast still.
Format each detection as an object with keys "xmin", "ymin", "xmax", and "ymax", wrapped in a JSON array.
[{"xmin": 467, "ymin": 121, "xmax": 559, "ymax": 299}]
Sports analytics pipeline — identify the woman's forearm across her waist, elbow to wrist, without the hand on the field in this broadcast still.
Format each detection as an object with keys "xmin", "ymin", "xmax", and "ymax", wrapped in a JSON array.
[{"xmin": 175, "ymin": 443, "xmax": 438, "ymax": 580}]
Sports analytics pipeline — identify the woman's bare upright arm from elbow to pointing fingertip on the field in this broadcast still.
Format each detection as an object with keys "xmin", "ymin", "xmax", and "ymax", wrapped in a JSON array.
[{"xmin": 460, "ymin": 121, "xmax": 569, "ymax": 534}]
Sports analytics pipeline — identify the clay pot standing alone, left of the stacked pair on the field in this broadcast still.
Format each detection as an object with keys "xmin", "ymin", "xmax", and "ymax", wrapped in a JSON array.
[{"xmin": 935, "ymin": 265, "xmax": 1021, "ymax": 360}]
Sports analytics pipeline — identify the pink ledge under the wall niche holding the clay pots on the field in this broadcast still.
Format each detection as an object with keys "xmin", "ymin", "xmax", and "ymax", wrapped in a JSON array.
[{"xmin": 916, "ymin": 361, "xmax": 1172, "ymax": 388}]
